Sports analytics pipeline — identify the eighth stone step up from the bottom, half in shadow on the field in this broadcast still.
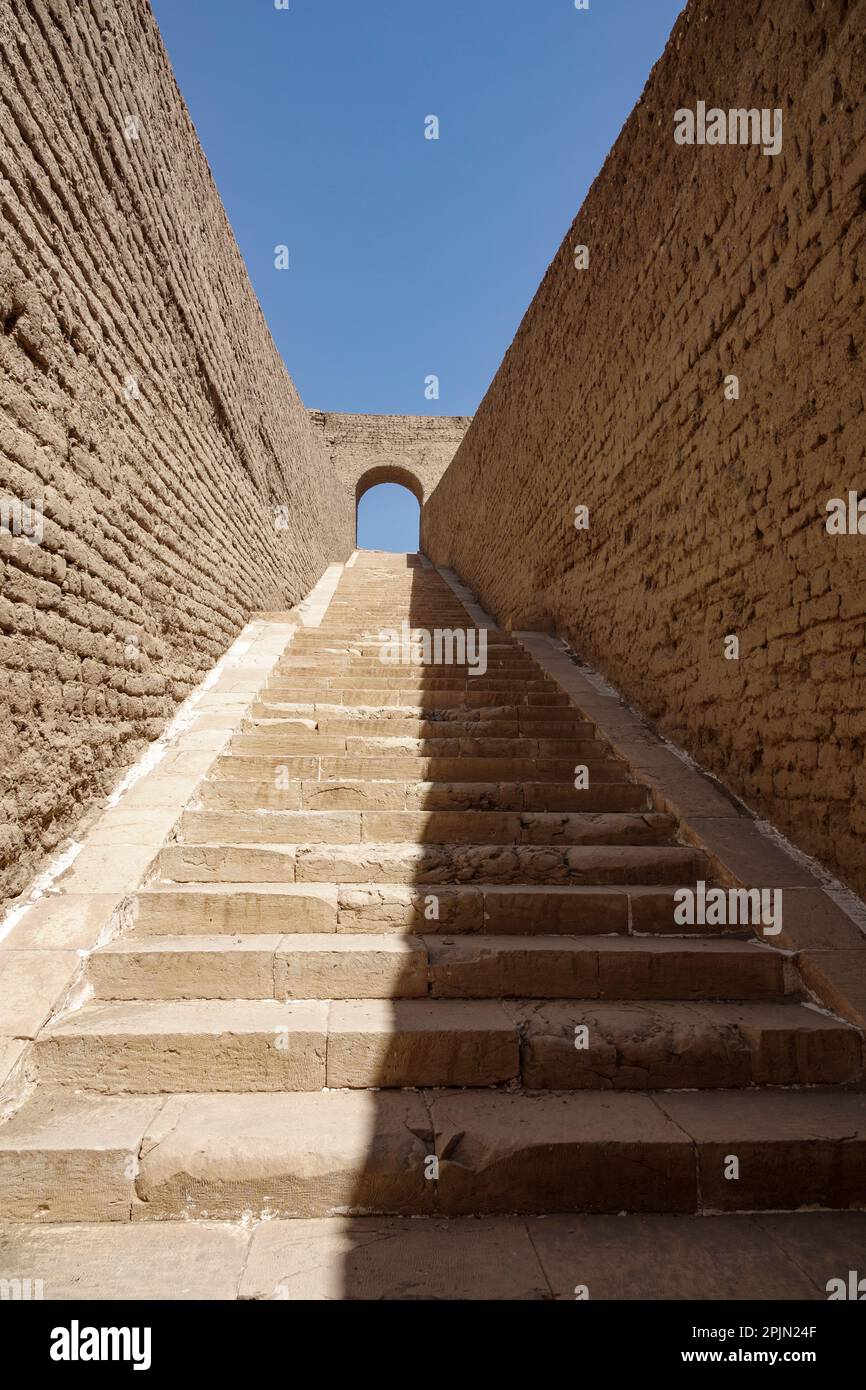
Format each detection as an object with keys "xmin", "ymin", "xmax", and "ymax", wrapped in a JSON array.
[{"xmin": 207, "ymin": 753, "xmax": 627, "ymax": 785}]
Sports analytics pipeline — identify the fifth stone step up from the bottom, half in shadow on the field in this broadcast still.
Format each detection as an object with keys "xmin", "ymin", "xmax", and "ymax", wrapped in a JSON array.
[{"xmin": 154, "ymin": 839, "xmax": 710, "ymax": 891}]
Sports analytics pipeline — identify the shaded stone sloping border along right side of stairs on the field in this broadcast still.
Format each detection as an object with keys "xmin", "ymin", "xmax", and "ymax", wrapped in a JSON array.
[{"xmin": 438, "ymin": 567, "xmax": 866, "ymax": 1029}]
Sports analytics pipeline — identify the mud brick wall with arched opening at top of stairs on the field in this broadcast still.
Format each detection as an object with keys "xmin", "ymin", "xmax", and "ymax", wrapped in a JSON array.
[{"xmin": 310, "ymin": 410, "xmax": 471, "ymax": 546}]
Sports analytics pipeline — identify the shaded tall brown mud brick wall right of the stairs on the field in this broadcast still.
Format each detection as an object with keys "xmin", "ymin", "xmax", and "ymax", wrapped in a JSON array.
[{"xmin": 423, "ymin": 0, "xmax": 866, "ymax": 891}]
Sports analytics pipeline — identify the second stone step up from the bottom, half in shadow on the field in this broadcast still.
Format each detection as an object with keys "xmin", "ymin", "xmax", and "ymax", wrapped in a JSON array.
[{"xmin": 28, "ymin": 995, "xmax": 862, "ymax": 1094}]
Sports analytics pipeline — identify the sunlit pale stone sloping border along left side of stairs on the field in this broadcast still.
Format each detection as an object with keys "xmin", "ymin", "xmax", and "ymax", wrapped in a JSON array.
[{"xmin": 0, "ymin": 564, "xmax": 343, "ymax": 1113}]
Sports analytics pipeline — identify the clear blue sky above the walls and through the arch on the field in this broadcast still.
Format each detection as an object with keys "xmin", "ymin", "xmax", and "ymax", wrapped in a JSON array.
[{"xmin": 152, "ymin": 0, "xmax": 683, "ymax": 549}]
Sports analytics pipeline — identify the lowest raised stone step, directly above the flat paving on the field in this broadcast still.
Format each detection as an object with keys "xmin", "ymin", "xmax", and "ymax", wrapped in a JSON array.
[{"xmin": 0, "ymin": 1088, "xmax": 866, "ymax": 1217}]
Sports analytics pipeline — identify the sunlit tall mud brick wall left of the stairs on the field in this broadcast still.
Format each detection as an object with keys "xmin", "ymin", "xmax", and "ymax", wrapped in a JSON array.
[{"xmin": 0, "ymin": 0, "xmax": 349, "ymax": 897}]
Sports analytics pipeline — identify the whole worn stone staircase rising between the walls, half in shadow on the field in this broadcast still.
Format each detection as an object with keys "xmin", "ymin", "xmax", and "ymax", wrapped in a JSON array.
[{"xmin": 0, "ymin": 552, "xmax": 866, "ymax": 1284}]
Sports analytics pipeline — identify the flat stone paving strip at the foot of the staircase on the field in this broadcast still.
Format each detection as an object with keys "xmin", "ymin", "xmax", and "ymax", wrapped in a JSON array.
[{"xmin": 0, "ymin": 1212, "xmax": 866, "ymax": 1302}]
